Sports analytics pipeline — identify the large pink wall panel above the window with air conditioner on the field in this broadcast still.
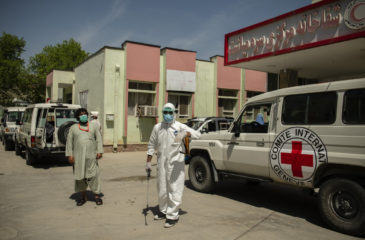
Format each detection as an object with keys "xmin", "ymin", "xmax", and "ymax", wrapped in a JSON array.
[{"xmin": 126, "ymin": 42, "xmax": 160, "ymax": 82}]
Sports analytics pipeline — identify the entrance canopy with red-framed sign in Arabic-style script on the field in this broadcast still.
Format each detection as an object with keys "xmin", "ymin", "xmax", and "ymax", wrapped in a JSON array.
[{"xmin": 225, "ymin": 0, "xmax": 365, "ymax": 79}]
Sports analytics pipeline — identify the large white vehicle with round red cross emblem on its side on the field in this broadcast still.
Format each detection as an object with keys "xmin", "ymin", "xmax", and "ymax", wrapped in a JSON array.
[{"xmin": 189, "ymin": 78, "xmax": 365, "ymax": 235}]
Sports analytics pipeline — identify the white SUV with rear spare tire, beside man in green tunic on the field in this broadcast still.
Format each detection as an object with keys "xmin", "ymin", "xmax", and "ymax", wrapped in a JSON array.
[{"xmin": 15, "ymin": 103, "xmax": 80, "ymax": 165}]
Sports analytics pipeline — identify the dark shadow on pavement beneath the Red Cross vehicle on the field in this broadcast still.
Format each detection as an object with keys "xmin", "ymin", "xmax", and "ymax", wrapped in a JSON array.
[{"xmin": 185, "ymin": 180, "xmax": 329, "ymax": 229}]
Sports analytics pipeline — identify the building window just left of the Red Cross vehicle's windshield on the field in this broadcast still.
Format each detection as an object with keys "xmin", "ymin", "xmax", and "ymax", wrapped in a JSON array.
[{"xmin": 218, "ymin": 89, "xmax": 238, "ymax": 117}]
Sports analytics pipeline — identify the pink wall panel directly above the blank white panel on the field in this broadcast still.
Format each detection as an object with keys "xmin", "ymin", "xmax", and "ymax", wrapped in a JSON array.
[{"xmin": 166, "ymin": 48, "xmax": 196, "ymax": 72}]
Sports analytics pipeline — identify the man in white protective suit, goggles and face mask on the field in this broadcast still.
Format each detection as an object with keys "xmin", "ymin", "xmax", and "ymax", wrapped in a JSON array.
[{"xmin": 146, "ymin": 103, "xmax": 200, "ymax": 228}]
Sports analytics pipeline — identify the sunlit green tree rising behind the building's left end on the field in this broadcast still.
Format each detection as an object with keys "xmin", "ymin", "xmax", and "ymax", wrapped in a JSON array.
[{"xmin": 26, "ymin": 38, "xmax": 88, "ymax": 102}]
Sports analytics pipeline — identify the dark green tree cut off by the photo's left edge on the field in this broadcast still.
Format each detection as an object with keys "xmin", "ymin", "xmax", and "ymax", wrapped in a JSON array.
[{"xmin": 0, "ymin": 32, "xmax": 25, "ymax": 106}]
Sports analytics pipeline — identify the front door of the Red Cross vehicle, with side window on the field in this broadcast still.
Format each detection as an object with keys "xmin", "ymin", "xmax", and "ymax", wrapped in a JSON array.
[{"xmin": 224, "ymin": 103, "xmax": 272, "ymax": 177}]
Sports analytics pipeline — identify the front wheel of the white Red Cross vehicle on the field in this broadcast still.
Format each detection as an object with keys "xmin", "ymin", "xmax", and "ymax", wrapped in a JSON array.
[{"xmin": 189, "ymin": 156, "xmax": 214, "ymax": 193}]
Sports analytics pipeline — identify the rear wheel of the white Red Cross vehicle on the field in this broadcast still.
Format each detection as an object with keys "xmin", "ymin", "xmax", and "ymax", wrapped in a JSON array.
[{"xmin": 318, "ymin": 178, "xmax": 365, "ymax": 236}]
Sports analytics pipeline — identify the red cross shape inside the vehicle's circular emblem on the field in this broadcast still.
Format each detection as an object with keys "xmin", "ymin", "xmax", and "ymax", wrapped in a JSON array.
[{"xmin": 281, "ymin": 141, "xmax": 313, "ymax": 177}]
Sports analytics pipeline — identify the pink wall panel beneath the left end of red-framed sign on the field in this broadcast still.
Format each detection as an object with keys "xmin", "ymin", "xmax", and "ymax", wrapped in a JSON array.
[{"xmin": 217, "ymin": 57, "xmax": 241, "ymax": 89}]
